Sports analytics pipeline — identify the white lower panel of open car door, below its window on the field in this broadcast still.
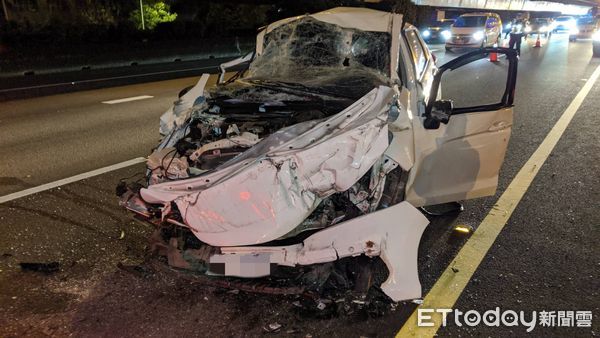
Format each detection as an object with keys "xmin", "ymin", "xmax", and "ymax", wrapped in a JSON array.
[{"xmin": 406, "ymin": 108, "xmax": 513, "ymax": 206}]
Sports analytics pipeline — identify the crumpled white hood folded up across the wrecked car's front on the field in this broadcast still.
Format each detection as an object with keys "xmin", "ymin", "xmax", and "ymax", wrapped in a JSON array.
[{"xmin": 141, "ymin": 87, "xmax": 393, "ymax": 246}]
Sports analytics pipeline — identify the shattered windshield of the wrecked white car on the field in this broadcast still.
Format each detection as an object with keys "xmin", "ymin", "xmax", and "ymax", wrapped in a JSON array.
[{"xmin": 247, "ymin": 17, "xmax": 391, "ymax": 97}]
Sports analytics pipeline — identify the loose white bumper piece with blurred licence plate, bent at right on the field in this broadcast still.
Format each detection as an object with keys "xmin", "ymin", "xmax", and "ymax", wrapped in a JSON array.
[{"xmin": 210, "ymin": 202, "xmax": 429, "ymax": 301}]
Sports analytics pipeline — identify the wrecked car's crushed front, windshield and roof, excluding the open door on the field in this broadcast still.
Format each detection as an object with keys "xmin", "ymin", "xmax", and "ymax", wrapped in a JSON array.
[{"xmin": 118, "ymin": 8, "xmax": 428, "ymax": 301}]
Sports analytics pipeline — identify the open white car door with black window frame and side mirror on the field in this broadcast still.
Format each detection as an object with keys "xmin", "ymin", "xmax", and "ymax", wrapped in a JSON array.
[{"xmin": 406, "ymin": 48, "xmax": 518, "ymax": 206}]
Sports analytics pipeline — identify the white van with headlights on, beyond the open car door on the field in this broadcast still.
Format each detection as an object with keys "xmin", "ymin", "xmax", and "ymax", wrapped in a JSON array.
[{"xmin": 446, "ymin": 13, "xmax": 502, "ymax": 51}]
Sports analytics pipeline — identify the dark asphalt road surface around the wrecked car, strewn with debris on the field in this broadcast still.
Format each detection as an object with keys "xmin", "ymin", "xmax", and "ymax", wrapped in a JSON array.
[{"xmin": 0, "ymin": 35, "xmax": 600, "ymax": 337}]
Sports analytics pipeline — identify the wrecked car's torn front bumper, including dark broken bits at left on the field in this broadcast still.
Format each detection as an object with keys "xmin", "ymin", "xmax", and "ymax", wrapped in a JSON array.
[{"xmin": 122, "ymin": 192, "xmax": 429, "ymax": 301}]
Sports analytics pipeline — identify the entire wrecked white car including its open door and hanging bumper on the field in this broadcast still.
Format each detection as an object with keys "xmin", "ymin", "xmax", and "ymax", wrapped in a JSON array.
[{"xmin": 118, "ymin": 8, "xmax": 517, "ymax": 301}]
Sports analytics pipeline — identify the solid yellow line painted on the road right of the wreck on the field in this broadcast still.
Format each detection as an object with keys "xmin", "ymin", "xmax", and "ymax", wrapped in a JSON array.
[{"xmin": 396, "ymin": 66, "xmax": 600, "ymax": 337}]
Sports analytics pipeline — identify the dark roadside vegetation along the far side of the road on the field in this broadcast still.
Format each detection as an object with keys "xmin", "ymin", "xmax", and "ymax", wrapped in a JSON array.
[{"xmin": 0, "ymin": 0, "xmax": 416, "ymax": 74}]
